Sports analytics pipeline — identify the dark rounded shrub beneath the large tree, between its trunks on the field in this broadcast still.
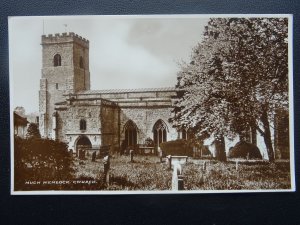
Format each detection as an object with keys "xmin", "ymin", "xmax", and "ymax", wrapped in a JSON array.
[{"xmin": 228, "ymin": 141, "xmax": 262, "ymax": 159}]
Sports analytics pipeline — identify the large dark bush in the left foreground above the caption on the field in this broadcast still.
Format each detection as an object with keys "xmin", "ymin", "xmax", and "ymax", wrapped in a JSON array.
[{"xmin": 14, "ymin": 137, "xmax": 72, "ymax": 190}]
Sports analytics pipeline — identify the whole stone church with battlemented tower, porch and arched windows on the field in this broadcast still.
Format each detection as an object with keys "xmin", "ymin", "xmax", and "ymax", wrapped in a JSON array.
[{"xmin": 39, "ymin": 32, "xmax": 181, "ymax": 154}]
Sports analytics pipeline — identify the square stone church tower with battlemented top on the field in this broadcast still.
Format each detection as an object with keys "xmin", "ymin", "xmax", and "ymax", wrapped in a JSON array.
[{"xmin": 39, "ymin": 32, "xmax": 90, "ymax": 138}]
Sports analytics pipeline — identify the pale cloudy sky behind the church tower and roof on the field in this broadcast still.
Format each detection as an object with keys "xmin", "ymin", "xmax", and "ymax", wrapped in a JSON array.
[{"xmin": 9, "ymin": 16, "xmax": 208, "ymax": 114}]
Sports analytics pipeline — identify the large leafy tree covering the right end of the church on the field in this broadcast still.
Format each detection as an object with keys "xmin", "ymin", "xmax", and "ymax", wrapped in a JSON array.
[{"xmin": 172, "ymin": 18, "xmax": 288, "ymax": 161}]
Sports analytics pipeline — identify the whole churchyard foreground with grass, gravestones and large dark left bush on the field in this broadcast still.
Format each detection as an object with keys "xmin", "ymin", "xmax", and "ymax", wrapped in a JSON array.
[{"xmin": 14, "ymin": 135, "xmax": 291, "ymax": 191}]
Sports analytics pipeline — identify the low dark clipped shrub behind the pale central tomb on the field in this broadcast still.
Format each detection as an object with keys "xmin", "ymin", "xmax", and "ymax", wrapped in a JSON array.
[{"xmin": 160, "ymin": 139, "xmax": 193, "ymax": 157}]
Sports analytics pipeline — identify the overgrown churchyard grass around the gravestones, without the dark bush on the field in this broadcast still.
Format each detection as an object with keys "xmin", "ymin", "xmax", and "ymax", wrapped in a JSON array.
[{"xmin": 73, "ymin": 156, "xmax": 291, "ymax": 190}]
